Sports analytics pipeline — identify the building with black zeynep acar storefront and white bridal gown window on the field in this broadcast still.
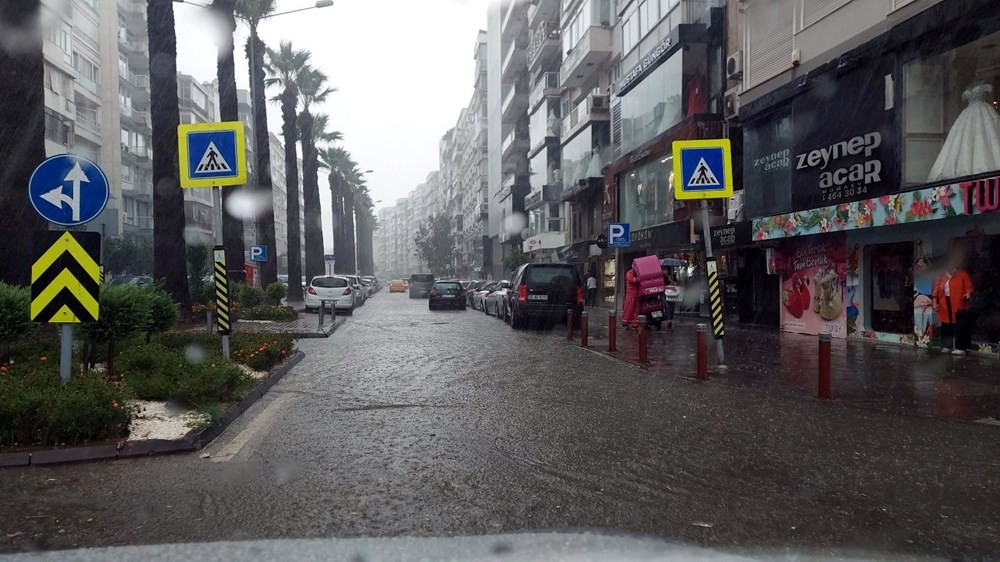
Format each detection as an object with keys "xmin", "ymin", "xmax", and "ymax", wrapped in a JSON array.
[{"xmin": 726, "ymin": 0, "xmax": 1000, "ymax": 353}]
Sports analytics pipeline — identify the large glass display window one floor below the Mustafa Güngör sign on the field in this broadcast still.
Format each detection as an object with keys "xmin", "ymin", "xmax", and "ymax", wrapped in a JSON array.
[{"xmin": 618, "ymin": 157, "xmax": 674, "ymax": 230}]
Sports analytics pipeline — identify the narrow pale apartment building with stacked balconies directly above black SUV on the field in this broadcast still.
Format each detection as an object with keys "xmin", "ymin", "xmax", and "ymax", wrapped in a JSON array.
[{"xmin": 521, "ymin": 0, "xmax": 570, "ymax": 263}]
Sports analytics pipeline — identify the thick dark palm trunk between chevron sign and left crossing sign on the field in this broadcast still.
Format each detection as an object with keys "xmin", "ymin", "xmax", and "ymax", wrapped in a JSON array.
[{"xmin": 146, "ymin": 0, "xmax": 191, "ymax": 310}]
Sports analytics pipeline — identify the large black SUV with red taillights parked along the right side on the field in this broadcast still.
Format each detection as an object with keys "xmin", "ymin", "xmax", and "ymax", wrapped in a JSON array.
[{"xmin": 504, "ymin": 263, "xmax": 583, "ymax": 330}]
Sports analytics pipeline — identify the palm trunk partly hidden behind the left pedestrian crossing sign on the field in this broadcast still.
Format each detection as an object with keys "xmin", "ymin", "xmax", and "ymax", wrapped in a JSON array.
[{"xmin": 212, "ymin": 0, "xmax": 246, "ymax": 283}]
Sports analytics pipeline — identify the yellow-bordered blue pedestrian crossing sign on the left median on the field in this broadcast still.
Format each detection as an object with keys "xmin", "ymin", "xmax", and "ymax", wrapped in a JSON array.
[{"xmin": 177, "ymin": 121, "xmax": 247, "ymax": 187}]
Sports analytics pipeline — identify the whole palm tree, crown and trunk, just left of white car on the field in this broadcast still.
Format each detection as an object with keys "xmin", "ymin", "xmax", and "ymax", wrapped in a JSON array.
[{"xmin": 266, "ymin": 41, "xmax": 311, "ymax": 302}]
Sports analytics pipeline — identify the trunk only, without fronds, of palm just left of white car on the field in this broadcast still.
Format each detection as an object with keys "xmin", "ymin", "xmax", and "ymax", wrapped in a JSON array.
[{"xmin": 281, "ymin": 83, "xmax": 302, "ymax": 302}]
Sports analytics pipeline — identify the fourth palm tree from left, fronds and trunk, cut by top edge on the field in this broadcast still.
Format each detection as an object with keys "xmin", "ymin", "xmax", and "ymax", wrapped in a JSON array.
[{"xmin": 236, "ymin": 0, "xmax": 278, "ymax": 285}]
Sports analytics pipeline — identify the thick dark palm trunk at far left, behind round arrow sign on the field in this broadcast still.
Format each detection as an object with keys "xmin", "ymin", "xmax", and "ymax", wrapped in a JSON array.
[{"xmin": 0, "ymin": 0, "xmax": 48, "ymax": 285}]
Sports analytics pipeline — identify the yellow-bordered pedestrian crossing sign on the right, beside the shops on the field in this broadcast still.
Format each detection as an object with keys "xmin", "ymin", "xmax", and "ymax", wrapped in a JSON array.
[{"xmin": 673, "ymin": 139, "xmax": 733, "ymax": 199}]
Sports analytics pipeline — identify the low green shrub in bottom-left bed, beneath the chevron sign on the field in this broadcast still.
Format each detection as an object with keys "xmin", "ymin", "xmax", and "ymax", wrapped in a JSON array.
[{"xmin": 0, "ymin": 365, "xmax": 133, "ymax": 446}]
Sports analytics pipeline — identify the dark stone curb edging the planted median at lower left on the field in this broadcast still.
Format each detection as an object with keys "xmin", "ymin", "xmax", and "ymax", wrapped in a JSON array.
[{"xmin": 0, "ymin": 351, "xmax": 305, "ymax": 469}]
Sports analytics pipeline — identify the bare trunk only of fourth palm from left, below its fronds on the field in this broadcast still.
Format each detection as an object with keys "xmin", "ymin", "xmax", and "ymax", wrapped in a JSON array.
[{"xmin": 247, "ymin": 26, "xmax": 278, "ymax": 287}]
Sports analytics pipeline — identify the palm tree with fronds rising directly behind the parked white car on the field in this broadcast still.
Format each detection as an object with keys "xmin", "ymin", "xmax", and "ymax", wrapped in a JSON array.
[{"xmin": 298, "ymin": 68, "xmax": 340, "ymax": 279}]
